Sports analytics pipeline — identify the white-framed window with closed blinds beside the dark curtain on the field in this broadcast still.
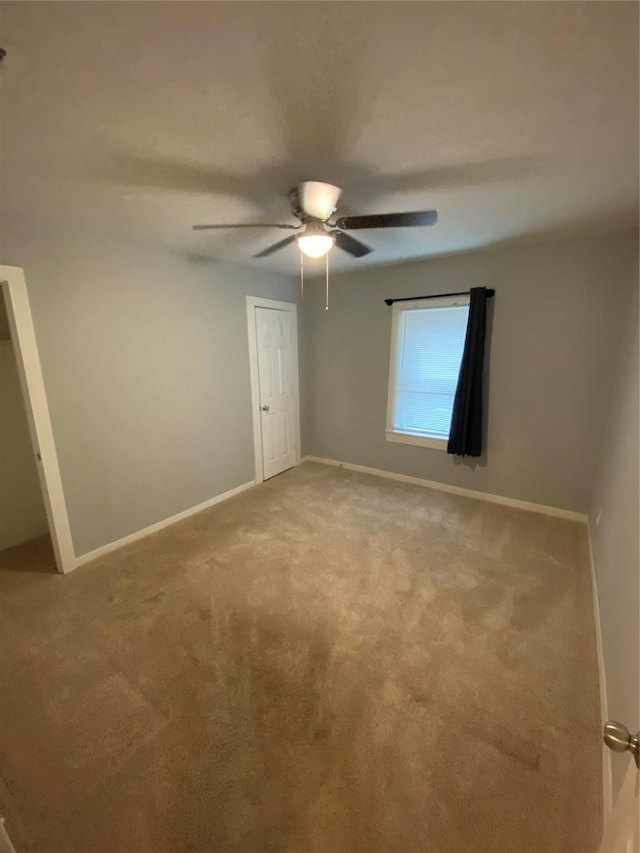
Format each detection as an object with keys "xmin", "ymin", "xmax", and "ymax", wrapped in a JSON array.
[{"xmin": 386, "ymin": 296, "xmax": 469, "ymax": 449}]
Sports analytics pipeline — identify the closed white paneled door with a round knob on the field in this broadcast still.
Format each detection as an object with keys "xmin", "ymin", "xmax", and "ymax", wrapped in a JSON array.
[{"xmin": 255, "ymin": 307, "xmax": 297, "ymax": 480}]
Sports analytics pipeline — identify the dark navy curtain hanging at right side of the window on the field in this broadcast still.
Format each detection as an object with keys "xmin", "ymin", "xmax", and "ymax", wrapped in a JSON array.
[{"xmin": 447, "ymin": 287, "xmax": 487, "ymax": 456}]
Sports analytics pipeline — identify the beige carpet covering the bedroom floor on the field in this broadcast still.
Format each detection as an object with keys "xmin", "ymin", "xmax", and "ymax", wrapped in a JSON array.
[{"xmin": 0, "ymin": 463, "xmax": 601, "ymax": 853}]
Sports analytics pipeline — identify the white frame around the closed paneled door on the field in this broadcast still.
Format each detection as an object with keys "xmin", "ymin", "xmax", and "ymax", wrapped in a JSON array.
[{"xmin": 246, "ymin": 296, "xmax": 300, "ymax": 483}]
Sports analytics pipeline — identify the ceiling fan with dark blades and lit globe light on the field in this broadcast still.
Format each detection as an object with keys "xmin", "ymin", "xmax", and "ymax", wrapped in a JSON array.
[{"xmin": 193, "ymin": 181, "xmax": 438, "ymax": 258}]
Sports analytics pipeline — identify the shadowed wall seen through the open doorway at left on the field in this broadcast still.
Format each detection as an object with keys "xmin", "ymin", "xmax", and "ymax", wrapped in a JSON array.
[{"xmin": 0, "ymin": 336, "xmax": 49, "ymax": 549}]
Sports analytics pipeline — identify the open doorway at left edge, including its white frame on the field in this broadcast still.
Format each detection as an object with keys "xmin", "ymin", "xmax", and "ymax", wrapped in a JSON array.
[{"xmin": 0, "ymin": 267, "xmax": 75, "ymax": 572}]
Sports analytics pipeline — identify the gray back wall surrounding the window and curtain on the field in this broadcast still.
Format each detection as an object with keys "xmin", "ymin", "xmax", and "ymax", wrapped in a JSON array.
[{"xmin": 303, "ymin": 226, "xmax": 638, "ymax": 512}]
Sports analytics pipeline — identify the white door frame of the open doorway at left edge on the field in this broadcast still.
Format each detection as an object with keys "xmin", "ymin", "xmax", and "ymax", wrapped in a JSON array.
[{"xmin": 0, "ymin": 265, "xmax": 76, "ymax": 572}]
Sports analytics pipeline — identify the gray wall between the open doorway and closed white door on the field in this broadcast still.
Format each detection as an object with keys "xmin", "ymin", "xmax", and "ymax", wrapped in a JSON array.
[{"xmin": 1, "ymin": 224, "xmax": 297, "ymax": 555}]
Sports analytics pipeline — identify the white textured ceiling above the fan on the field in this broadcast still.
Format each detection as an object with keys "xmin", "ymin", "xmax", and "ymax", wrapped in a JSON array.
[{"xmin": 0, "ymin": 2, "xmax": 638, "ymax": 271}]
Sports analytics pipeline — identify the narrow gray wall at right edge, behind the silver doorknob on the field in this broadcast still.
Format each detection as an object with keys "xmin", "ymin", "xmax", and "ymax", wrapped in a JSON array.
[{"xmin": 590, "ymin": 259, "xmax": 640, "ymax": 797}]
